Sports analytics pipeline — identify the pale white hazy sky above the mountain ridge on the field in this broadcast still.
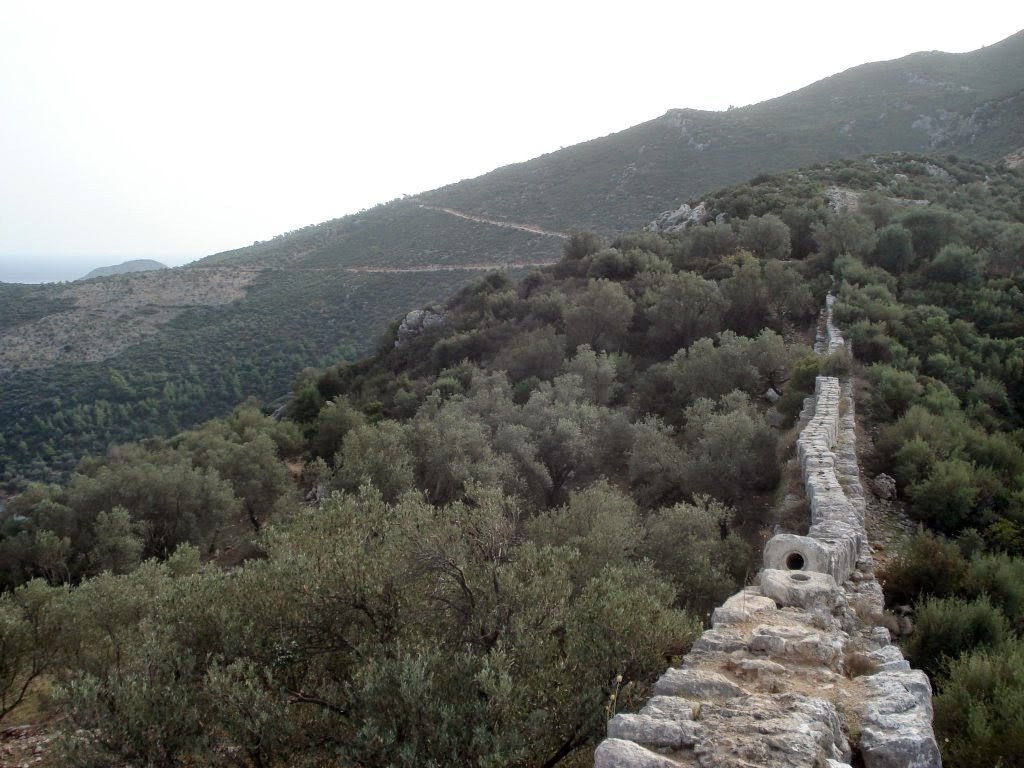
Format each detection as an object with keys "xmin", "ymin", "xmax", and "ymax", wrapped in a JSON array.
[{"xmin": 0, "ymin": 0, "xmax": 1024, "ymax": 280}]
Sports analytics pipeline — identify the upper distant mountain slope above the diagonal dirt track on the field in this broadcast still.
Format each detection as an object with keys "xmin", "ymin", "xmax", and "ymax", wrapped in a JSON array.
[{"xmin": 424, "ymin": 32, "xmax": 1024, "ymax": 232}]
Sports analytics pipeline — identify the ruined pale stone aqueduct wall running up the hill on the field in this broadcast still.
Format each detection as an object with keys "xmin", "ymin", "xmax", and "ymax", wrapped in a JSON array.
[{"xmin": 594, "ymin": 296, "xmax": 941, "ymax": 768}]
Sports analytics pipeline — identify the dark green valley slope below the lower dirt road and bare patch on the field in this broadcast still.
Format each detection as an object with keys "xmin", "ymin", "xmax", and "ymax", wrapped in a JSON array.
[{"xmin": 0, "ymin": 268, "xmax": 544, "ymax": 493}]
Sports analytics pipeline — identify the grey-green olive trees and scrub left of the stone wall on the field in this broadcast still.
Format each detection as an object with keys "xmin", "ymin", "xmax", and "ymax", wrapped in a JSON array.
[{"xmin": 0, "ymin": 173, "xmax": 839, "ymax": 766}]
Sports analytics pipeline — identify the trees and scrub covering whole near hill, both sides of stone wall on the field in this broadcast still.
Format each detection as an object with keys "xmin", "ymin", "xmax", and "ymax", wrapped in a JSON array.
[{"xmin": 0, "ymin": 156, "xmax": 1024, "ymax": 766}]
